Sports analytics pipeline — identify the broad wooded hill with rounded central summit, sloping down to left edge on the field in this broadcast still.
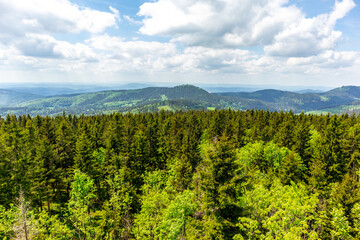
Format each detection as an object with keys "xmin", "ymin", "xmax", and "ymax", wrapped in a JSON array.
[{"xmin": 0, "ymin": 85, "xmax": 222, "ymax": 115}]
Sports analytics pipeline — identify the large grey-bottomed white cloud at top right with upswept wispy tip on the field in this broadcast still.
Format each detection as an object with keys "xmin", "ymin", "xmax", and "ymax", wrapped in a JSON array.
[{"xmin": 138, "ymin": 0, "xmax": 355, "ymax": 57}]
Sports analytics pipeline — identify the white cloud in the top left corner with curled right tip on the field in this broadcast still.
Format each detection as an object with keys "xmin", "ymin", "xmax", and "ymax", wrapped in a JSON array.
[{"xmin": 0, "ymin": 0, "xmax": 119, "ymax": 41}]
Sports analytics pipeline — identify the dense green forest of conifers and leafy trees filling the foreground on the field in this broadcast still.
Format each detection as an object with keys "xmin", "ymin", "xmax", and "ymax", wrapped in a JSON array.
[{"xmin": 0, "ymin": 109, "xmax": 360, "ymax": 240}]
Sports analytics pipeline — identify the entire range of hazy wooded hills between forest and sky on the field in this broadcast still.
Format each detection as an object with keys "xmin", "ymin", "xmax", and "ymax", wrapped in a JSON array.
[{"xmin": 0, "ymin": 85, "xmax": 360, "ymax": 116}]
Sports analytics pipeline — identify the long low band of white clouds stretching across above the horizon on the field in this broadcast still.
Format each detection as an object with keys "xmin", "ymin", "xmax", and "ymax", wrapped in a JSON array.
[{"xmin": 0, "ymin": 31, "xmax": 360, "ymax": 76}]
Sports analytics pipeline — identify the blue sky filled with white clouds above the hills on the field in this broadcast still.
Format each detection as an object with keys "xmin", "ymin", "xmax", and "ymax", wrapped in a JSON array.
[{"xmin": 0, "ymin": 0, "xmax": 360, "ymax": 87}]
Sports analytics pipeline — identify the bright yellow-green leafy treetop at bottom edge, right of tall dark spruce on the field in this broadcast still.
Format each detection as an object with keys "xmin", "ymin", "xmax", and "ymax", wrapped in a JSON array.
[{"xmin": 234, "ymin": 180, "xmax": 321, "ymax": 239}]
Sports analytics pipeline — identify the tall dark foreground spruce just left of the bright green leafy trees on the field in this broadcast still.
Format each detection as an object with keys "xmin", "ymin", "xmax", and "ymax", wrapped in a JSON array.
[{"xmin": 194, "ymin": 135, "xmax": 241, "ymax": 239}]
